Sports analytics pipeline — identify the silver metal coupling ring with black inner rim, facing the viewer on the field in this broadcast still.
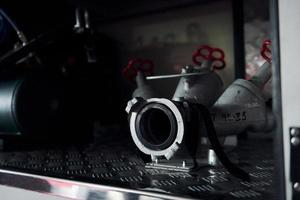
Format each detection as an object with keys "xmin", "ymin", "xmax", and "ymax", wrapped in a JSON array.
[{"xmin": 130, "ymin": 98, "xmax": 184, "ymax": 160}]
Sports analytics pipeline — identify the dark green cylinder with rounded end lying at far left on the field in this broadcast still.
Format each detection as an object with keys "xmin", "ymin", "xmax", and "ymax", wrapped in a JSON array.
[{"xmin": 0, "ymin": 76, "xmax": 66, "ymax": 135}]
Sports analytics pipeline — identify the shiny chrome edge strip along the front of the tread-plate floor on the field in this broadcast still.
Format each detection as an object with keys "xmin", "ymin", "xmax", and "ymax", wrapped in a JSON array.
[{"xmin": 0, "ymin": 169, "xmax": 197, "ymax": 200}]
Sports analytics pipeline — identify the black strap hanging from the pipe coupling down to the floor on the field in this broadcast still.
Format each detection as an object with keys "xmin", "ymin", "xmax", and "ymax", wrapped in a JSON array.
[{"xmin": 197, "ymin": 104, "xmax": 250, "ymax": 181}]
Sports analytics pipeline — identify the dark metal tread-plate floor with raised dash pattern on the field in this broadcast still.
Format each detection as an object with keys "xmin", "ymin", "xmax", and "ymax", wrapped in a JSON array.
[{"xmin": 0, "ymin": 139, "xmax": 274, "ymax": 200}]
